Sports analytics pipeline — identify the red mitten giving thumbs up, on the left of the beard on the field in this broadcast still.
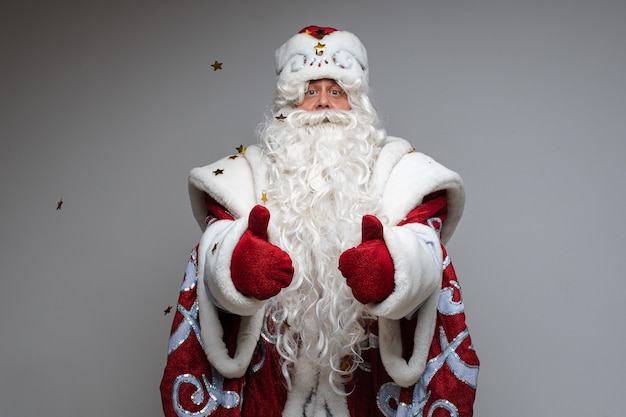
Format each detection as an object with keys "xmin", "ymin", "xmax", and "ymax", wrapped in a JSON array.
[{"xmin": 230, "ymin": 205, "xmax": 293, "ymax": 300}]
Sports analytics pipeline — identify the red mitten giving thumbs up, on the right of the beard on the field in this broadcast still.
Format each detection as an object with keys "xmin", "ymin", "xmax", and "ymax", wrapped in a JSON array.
[{"xmin": 339, "ymin": 215, "xmax": 395, "ymax": 304}]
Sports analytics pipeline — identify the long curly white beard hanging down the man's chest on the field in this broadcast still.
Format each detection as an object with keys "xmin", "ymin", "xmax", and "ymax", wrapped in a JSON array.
[{"xmin": 261, "ymin": 111, "xmax": 382, "ymax": 392}]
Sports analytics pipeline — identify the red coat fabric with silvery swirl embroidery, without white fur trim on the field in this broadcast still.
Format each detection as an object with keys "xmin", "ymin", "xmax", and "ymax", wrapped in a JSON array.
[{"xmin": 160, "ymin": 139, "xmax": 479, "ymax": 417}]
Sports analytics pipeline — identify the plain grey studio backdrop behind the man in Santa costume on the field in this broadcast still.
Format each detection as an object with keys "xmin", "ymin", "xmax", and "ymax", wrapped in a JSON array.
[{"xmin": 0, "ymin": 0, "xmax": 626, "ymax": 417}]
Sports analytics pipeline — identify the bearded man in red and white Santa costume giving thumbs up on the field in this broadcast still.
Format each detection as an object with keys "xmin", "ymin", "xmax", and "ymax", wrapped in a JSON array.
[{"xmin": 161, "ymin": 26, "xmax": 479, "ymax": 417}]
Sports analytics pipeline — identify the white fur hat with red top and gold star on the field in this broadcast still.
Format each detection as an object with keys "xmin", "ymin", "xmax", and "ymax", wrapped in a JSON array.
[{"xmin": 275, "ymin": 26, "xmax": 368, "ymax": 88}]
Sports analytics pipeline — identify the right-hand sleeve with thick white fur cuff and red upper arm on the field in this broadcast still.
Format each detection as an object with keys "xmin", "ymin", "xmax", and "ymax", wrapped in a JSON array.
[{"xmin": 371, "ymin": 191, "xmax": 448, "ymax": 387}]
